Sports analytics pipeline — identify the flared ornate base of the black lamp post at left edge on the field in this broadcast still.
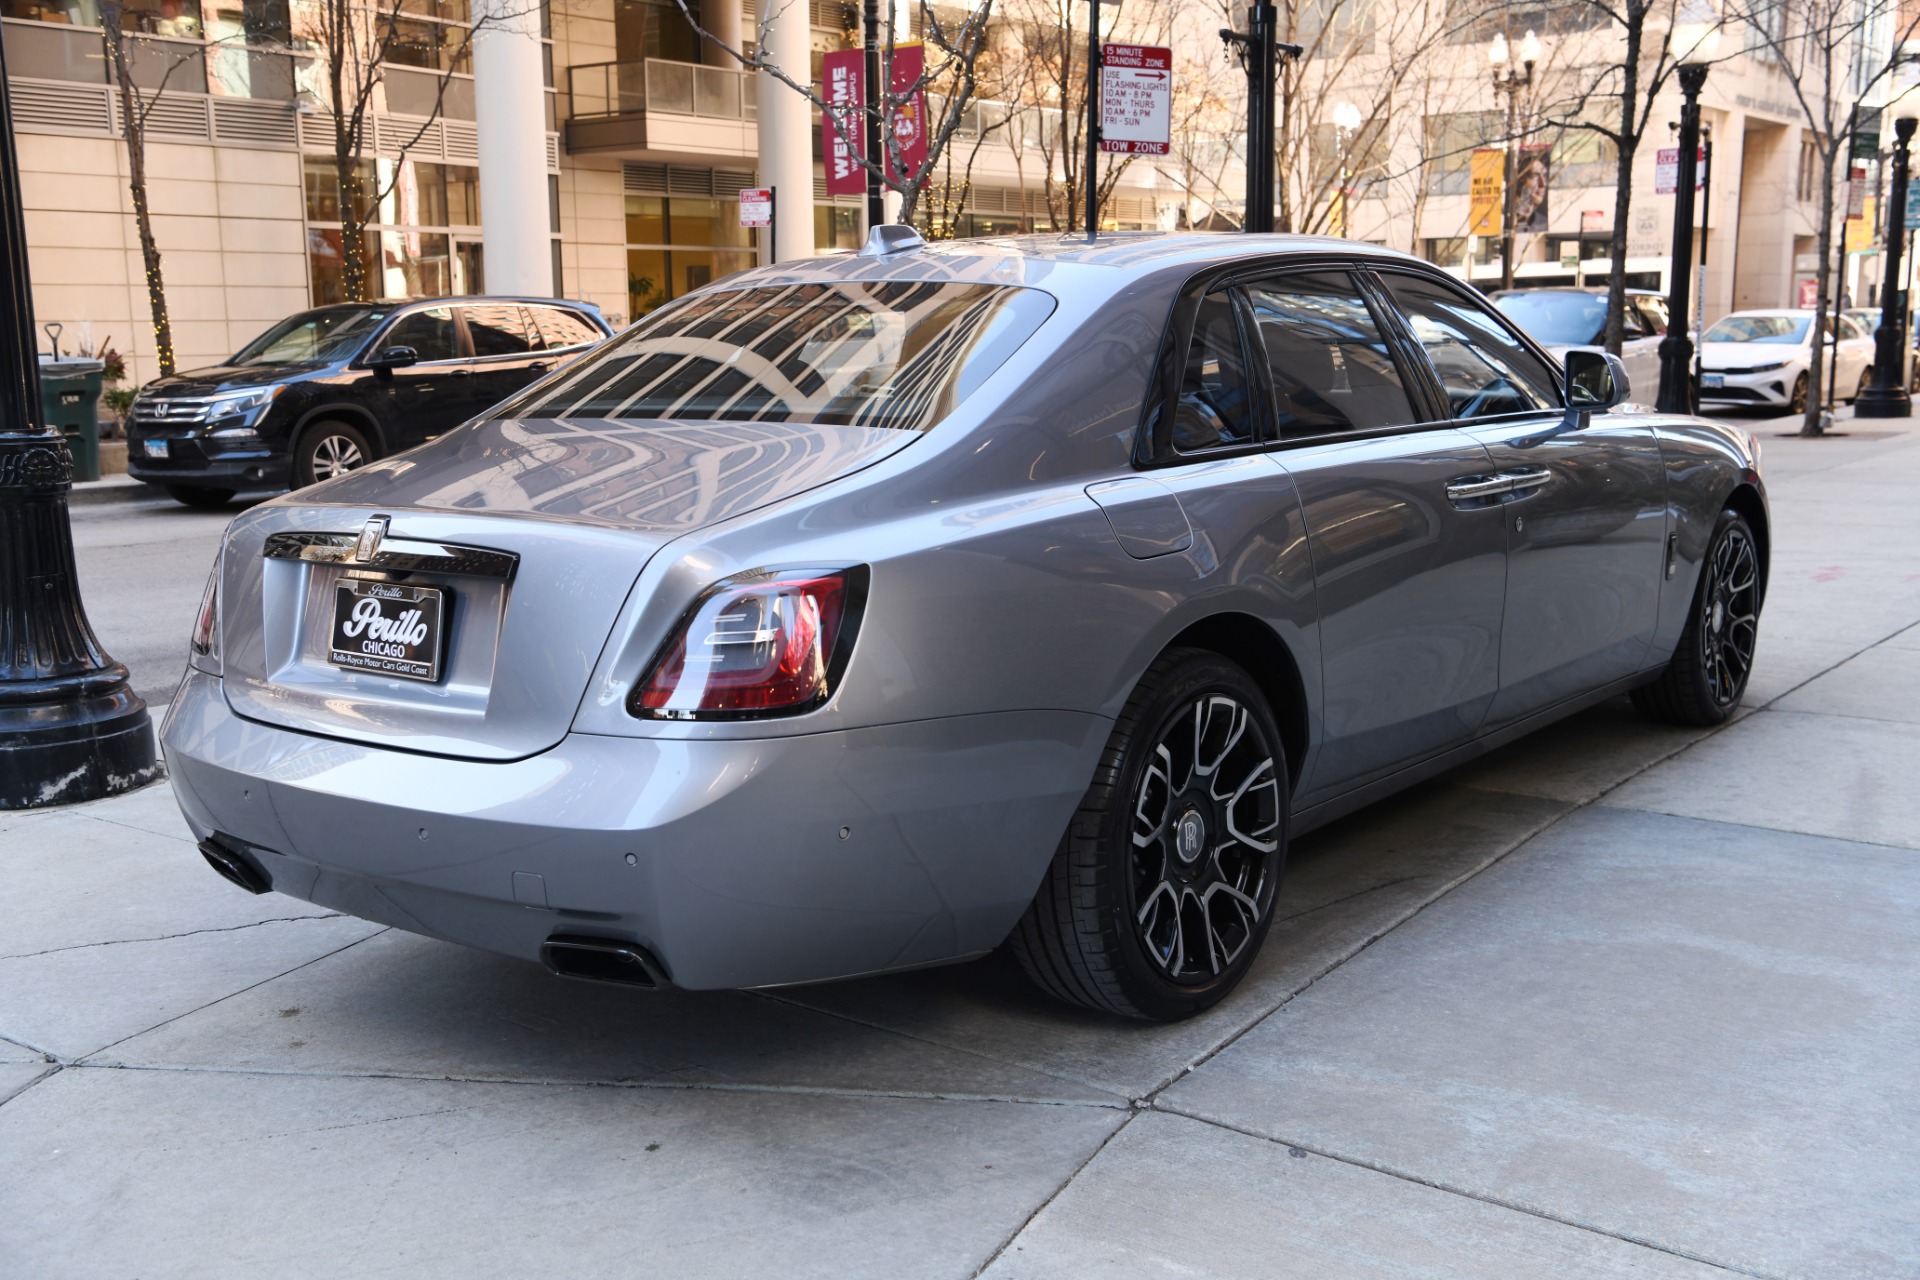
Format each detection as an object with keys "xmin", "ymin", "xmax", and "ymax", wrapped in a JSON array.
[{"xmin": 0, "ymin": 432, "xmax": 161, "ymax": 810}]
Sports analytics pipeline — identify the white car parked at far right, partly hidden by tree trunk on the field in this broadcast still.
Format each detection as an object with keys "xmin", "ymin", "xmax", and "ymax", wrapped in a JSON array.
[{"xmin": 1699, "ymin": 311, "xmax": 1874, "ymax": 413}]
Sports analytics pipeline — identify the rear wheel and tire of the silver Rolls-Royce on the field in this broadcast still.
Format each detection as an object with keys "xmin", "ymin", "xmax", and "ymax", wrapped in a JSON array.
[{"xmin": 1010, "ymin": 649, "xmax": 1290, "ymax": 1021}]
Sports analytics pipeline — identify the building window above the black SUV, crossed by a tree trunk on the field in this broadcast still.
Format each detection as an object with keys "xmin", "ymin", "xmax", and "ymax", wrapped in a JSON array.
[{"xmin": 305, "ymin": 155, "xmax": 486, "ymax": 307}]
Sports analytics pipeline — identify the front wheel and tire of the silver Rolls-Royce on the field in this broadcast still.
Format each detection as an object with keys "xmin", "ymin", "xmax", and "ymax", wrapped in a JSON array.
[{"xmin": 1634, "ymin": 510, "xmax": 1761, "ymax": 727}]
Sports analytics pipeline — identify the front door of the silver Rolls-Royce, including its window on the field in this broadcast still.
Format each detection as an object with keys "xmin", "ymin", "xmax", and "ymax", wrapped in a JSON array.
[{"xmin": 1380, "ymin": 271, "xmax": 1667, "ymax": 727}]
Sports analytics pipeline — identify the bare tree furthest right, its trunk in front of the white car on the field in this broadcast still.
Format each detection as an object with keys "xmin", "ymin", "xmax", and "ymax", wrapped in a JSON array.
[{"xmin": 1728, "ymin": 0, "xmax": 1920, "ymax": 436}]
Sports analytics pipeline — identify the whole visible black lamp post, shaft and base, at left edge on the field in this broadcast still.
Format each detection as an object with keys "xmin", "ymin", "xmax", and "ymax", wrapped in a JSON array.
[{"xmin": 0, "ymin": 50, "xmax": 159, "ymax": 810}]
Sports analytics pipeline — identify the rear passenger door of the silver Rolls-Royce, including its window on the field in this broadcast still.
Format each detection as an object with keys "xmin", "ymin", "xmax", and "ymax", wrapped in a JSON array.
[{"xmin": 1240, "ymin": 267, "xmax": 1507, "ymax": 802}]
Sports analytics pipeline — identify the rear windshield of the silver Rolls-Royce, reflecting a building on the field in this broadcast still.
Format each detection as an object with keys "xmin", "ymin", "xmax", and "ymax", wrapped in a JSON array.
[{"xmin": 503, "ymin": 280, "xmax": 1054, "ymax": 432}]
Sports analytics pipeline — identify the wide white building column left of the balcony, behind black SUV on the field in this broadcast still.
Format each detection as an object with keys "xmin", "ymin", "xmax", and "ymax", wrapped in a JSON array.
[{"xmin": 472, "ymin": 0, "xmax": 555, "ymax": 297}]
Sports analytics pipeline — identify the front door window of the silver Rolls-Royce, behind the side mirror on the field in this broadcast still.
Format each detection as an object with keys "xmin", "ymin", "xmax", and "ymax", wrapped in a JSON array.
[{"xmin": 1380, "ymin": 273, "xmax": 1559, "ymax": 420}]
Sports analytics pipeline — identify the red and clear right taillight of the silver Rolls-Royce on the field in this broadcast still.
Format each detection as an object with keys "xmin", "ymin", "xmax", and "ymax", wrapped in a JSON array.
[{"xmin": 632, "ymin": 570, "xmax": 858, "ymax": 720}]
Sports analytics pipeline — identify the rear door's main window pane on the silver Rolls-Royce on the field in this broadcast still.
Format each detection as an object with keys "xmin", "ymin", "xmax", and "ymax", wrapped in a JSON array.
[{"xmin": 1246, "ymin": 273, "xmax": 1417, "ymax": 439}]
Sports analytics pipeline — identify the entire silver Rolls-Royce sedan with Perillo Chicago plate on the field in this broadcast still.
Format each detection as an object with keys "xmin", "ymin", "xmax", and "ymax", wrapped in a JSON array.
[{"xmin": 163, "ymin": 228, "xmax": 1768, "ymax": 1019}]
